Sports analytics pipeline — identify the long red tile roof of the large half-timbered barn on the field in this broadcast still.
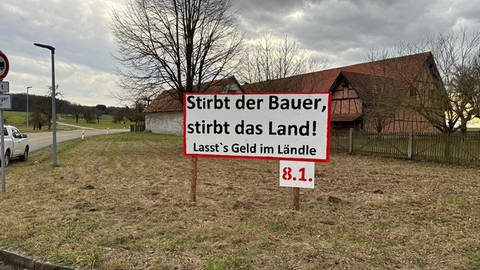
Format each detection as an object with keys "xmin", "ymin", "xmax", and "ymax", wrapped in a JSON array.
[{"xmin": 242, "ymin": 52, "xmax": 433, "ymax": 93}]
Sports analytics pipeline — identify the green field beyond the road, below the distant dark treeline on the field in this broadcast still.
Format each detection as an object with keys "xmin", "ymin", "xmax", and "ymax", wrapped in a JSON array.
[{"xmin": 4, "ymin": 111, "xmax": 130, "ymax": 132}]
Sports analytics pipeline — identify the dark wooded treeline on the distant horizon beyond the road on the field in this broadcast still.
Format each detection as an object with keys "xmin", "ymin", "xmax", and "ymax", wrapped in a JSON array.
[{"xmin": 10, "ymin": 94, "xmax": 123, "ymax": 115}]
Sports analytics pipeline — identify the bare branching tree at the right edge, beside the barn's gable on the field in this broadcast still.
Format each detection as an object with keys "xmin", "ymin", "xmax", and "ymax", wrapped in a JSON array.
[{"xmin": 400, "ymin": 29, "xmax": 480, "ymax": 133}]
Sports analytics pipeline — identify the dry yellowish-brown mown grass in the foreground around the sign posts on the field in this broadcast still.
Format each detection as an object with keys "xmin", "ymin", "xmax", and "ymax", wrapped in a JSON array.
[{"xmin": 0, "ymin": 134, "xmax": 480, "ymax": 269}]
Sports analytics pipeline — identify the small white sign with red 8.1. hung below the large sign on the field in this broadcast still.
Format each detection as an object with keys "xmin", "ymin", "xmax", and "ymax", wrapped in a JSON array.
[{"xmin": 279, "ymin": 160, "xmax": 315, "ymax": 188}]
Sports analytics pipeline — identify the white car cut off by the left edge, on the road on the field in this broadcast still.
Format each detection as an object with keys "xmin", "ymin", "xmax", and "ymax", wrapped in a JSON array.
[{"xmin": 0, "ymin": 125, "xmax": 30, "ymax": 166}]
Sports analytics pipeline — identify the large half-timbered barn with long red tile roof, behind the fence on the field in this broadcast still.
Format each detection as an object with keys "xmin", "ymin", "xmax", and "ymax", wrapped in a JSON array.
[{"xmin": 242, "ymin": 52, "xmax": 441, "ymax": 133}]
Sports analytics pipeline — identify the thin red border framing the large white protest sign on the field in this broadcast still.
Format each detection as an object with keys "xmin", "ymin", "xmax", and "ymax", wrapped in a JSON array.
[{"xmin": 183, "ymin": 92, "xmax": 332, "ymax": 162}]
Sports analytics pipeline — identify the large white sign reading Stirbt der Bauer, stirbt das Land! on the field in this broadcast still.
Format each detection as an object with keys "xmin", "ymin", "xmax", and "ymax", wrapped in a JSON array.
[{"xmin": 184, "ymin": 93, "xmax": 330, "ymax": 161}]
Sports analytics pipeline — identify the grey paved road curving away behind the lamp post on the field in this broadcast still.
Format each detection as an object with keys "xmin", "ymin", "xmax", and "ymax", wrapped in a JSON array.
[{"xmin": 28, "ymin": 129, "xmax": 130, "ymax": 152}]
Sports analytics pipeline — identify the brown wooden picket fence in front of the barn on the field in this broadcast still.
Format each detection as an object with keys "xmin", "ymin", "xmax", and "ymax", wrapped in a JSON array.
[{"xmin": 330, "ymin": 129, "xmax": 480, "ymax": 164}]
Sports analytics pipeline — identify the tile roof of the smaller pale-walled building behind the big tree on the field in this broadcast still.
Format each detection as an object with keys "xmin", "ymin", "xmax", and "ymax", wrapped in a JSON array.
[{"xmin": 144, "ymin": 76, "xmax": 240, "ymax": 113}]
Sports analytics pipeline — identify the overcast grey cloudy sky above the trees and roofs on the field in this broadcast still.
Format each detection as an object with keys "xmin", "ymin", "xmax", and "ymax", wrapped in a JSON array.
[{"xmin": 0, "ymin": 0, "xmax": 480, "ymax": 106}]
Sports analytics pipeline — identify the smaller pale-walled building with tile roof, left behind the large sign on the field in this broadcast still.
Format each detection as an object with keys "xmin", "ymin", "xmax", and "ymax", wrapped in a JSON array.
[{"xmin": 145, "ymin": 76, "xmax": 242, "ymax": 135}]
